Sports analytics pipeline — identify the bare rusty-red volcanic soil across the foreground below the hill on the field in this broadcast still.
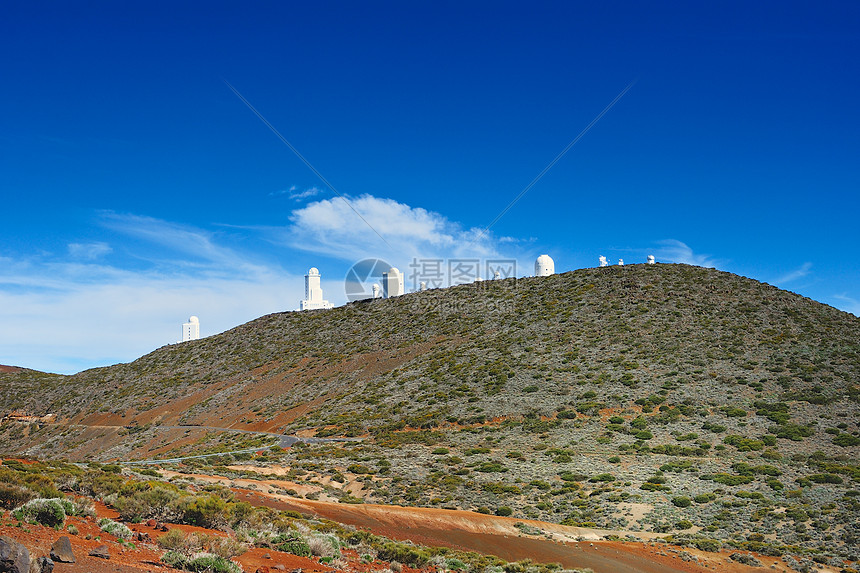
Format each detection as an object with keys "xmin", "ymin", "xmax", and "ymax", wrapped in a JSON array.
[{"xmin": 0, "ymin": 482, "xmax": 833, "ymax": 573}]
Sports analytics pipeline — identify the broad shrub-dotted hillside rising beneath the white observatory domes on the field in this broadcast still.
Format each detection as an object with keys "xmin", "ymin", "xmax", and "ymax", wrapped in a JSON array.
[{"xmin": 0, "ymin": 265, "xmax": 860, "ymax": 559}]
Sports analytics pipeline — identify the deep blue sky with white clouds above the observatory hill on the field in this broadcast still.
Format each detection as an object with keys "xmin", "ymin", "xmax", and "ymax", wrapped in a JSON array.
[{"xmin": 0, "ymin": 0, "xmax": 860, "ymax": 373}]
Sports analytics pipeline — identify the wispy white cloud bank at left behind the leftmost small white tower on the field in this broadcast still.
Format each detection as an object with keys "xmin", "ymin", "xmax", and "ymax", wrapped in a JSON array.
[{"xmin": 0, "ymin": 212, "xmax": 302, "ymax": 373}]
